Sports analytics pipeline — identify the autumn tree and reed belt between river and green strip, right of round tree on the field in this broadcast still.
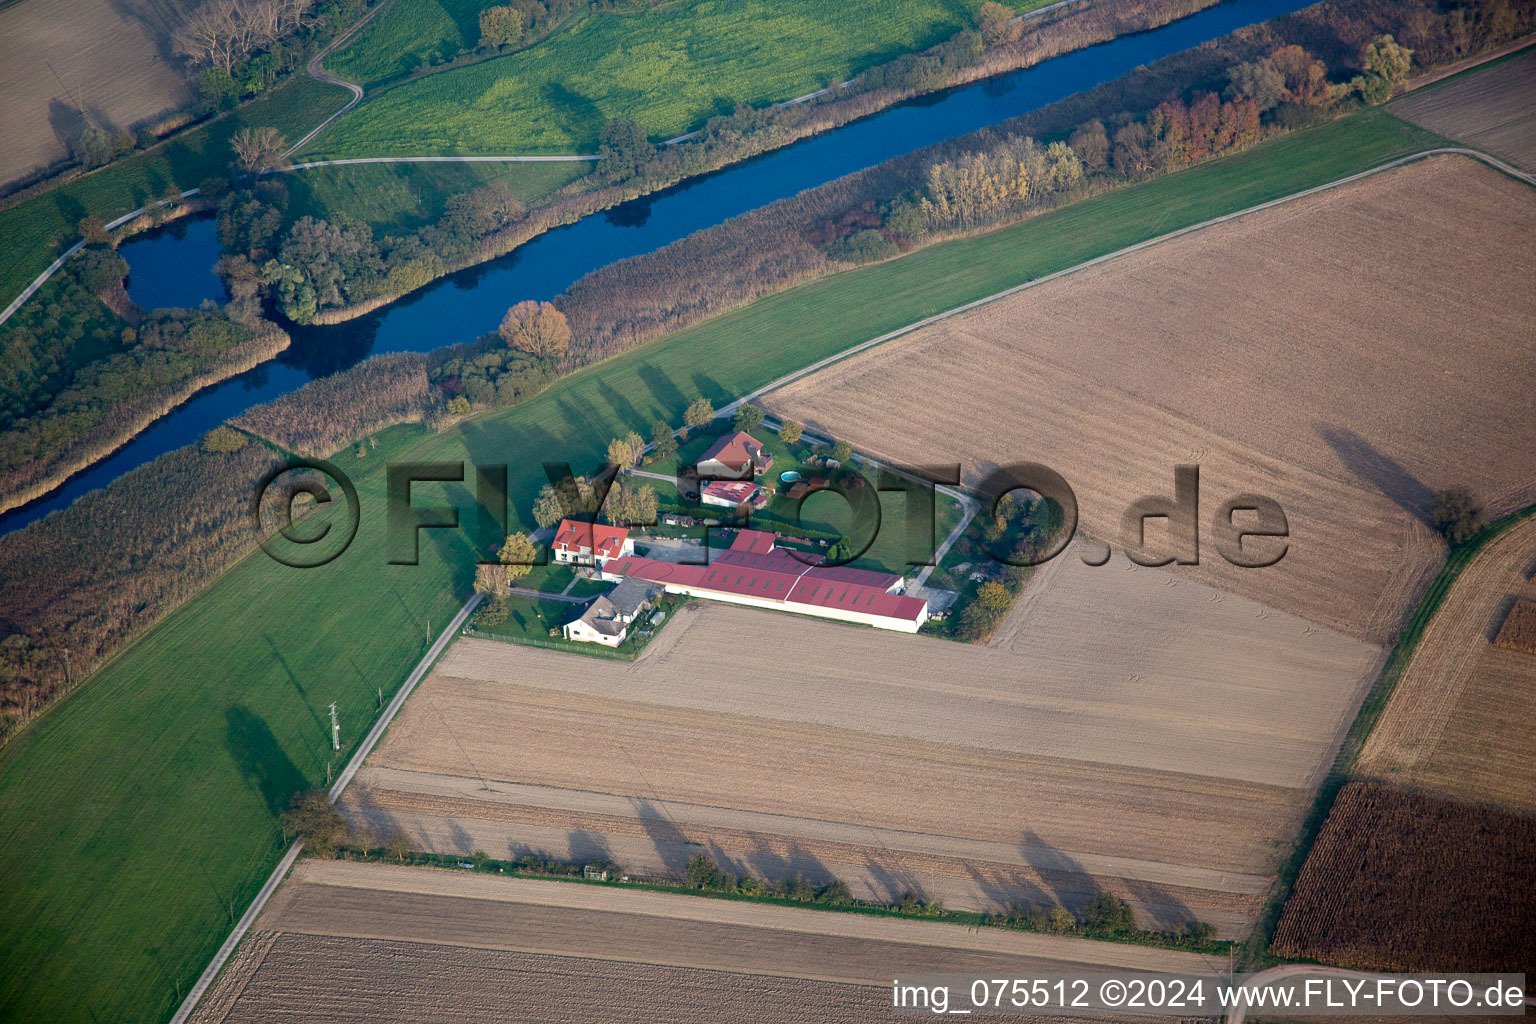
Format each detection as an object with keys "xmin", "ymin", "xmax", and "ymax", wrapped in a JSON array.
[{"xmin": 556, "ymin": 0, "xmax": 1536, "ymax": 361}]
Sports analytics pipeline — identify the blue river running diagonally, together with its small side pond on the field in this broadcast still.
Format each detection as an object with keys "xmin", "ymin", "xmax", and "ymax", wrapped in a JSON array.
[{"xmin": 0, "ymin": 0, "xmax": 1312, "ymax": 533}]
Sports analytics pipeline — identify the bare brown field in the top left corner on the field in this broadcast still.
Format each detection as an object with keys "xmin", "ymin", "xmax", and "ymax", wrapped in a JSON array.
[{"xmin": 0, "ymin": 0, "xmax": 195, "ymax": 183}]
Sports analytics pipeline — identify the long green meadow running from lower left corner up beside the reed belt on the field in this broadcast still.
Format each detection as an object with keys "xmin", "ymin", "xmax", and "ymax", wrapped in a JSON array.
[{"xmin": 0, "ymin": 111, "xmax": 1439, "ymax": 1024}]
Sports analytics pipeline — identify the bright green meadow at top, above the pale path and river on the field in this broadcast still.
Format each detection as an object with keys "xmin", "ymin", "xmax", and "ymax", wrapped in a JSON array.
[{"xmin": 309, "ymin": 0, "xmax": 1044, "ymax": 157}]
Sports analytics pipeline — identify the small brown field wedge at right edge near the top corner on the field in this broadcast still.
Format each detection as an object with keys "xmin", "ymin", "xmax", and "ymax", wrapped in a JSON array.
[{"xmin": 1387, "ymin": 49, "xmax": 1536, "ymax": 170}]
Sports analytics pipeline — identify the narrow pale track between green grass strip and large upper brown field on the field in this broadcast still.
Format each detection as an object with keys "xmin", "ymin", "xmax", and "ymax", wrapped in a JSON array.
[{"xmin": 737, "ymin": 146, "xmax": 1536, "ymax": 416}]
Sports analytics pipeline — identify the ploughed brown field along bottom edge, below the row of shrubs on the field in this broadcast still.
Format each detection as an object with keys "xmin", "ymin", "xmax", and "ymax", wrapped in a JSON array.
[{"xmin": 194, "ymin": 861, "xmax": 1206, "ymax": 1024}]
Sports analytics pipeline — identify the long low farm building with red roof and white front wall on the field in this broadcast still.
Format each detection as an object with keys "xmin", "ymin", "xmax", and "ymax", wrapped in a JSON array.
[{"xmin": 602, "ymin": 530, "xmax": 928, "ymax": 633}]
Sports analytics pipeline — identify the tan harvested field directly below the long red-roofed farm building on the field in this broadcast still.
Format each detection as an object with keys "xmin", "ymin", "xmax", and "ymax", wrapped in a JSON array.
[{"xmin": 344, "ymin": 559, "xmax": 1381, "ymax": 935}]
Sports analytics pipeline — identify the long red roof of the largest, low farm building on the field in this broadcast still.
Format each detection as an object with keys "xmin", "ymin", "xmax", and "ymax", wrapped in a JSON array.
[{"xmin": 604, "ymin": 540, "xmax": 926, "ymax": 622}]
